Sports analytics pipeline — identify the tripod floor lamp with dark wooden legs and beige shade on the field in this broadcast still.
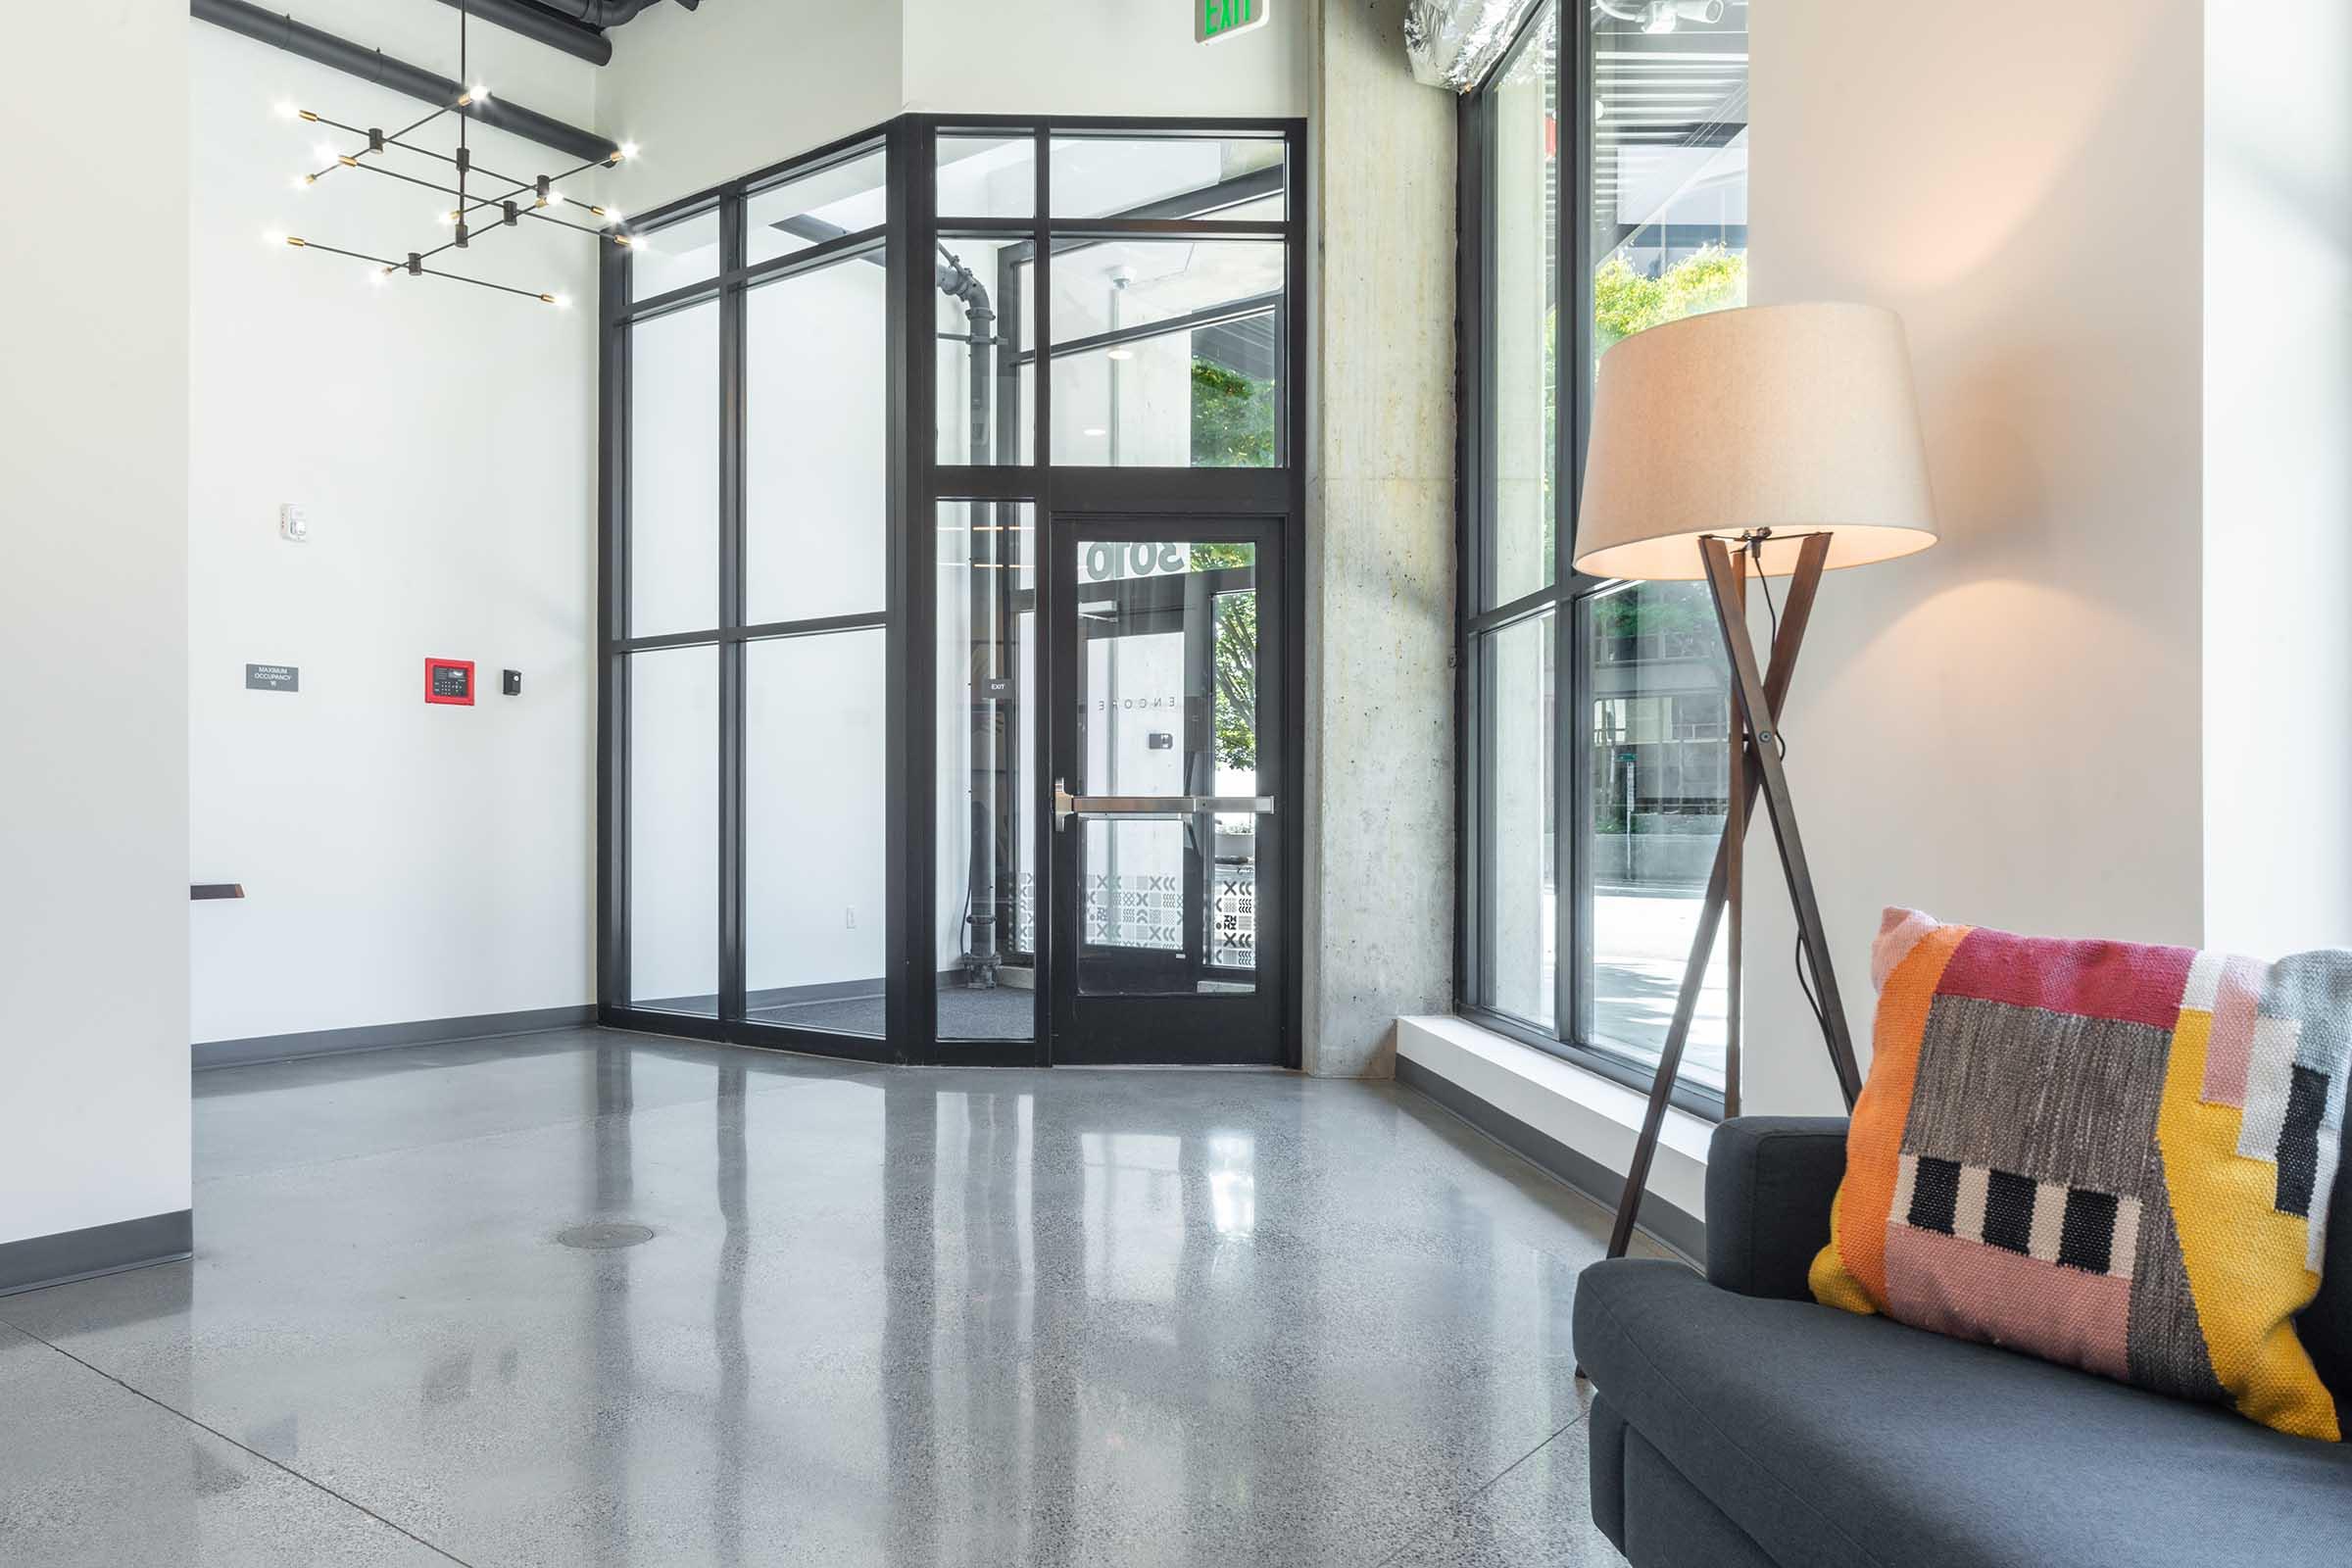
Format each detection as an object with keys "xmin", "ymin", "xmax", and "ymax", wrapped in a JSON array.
[{"xmin": 1576, "ymin": 306, "xmax": 1936, "ymax": 1257}]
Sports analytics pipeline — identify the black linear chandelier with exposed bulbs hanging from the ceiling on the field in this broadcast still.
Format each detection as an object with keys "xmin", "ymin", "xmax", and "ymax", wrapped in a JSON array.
[{"xmin": 264, "ymin": 2, "xmax": 637, "ymax": 308}]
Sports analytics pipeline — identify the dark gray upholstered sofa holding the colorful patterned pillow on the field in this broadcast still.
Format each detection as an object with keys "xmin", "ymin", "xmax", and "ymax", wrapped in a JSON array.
[{"xmin": 1576, "ymin": 1116, "xmax": 2352, "ymax": 1568}]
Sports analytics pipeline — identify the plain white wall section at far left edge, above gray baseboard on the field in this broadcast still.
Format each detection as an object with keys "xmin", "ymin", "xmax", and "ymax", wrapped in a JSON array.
[{"xmin": 0, "ymin": 0, "xmax": 190, "ymax": 1242}]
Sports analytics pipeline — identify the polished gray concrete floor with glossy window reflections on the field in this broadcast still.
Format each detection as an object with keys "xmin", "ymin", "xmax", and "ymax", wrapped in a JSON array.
[{"xmin": 0, "ymin": 1032, "xmax": 1618, "ymax": 1568}]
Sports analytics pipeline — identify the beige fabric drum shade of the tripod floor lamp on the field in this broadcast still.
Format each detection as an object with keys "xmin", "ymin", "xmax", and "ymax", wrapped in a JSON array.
[{"xmin": 1576, "ymin": 306, "xmax": 1936, "ymax": 581}]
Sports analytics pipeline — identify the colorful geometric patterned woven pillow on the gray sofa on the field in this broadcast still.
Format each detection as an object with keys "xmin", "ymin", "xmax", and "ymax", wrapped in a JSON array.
[{"xmin": 1811, "ymin": 909, "xmax": 2352, "ymax": 1441}]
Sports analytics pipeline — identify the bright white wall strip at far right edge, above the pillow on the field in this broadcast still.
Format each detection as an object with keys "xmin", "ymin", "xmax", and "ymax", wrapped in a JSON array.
[{"xmin": 2204, "ymin": 0, "xmax": 2352, "ymax": 956}]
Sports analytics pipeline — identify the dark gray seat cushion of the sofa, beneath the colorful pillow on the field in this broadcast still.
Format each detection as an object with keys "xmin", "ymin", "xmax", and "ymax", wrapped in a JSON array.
[{"xmin": 1576, "ymin": 1257, "xmax": 2352, "ymax": 1568}]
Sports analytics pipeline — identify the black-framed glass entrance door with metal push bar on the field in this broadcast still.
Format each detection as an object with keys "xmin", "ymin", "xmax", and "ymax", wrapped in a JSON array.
[{"xmin": 1052, "ymin": 519, "xmax": 1289, "ymax": 1062}]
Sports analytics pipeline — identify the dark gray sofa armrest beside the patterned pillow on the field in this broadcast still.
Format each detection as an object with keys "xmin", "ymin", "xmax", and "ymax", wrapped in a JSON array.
[{"xmin": 1707, "ymin": 1116, "xmax": 1846, "ymax": 1300}]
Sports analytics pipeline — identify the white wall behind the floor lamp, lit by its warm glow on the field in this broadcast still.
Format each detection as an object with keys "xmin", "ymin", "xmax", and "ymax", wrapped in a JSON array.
[{"xmin": 1745, "ymin": 0, "xmax": 2211, "ymax": 1112}]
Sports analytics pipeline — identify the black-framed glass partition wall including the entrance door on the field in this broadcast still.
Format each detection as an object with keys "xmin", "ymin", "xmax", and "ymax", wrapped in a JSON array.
[{"xmin": 598, "ymin": 116, "xmax": 1305, "ymax": 1065}]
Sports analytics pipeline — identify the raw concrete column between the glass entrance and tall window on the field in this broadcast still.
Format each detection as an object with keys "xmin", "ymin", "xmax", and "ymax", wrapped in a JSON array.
[{"xmin": 1303, "ymin": 0, "xmax": 1453, "ymax": 1077}]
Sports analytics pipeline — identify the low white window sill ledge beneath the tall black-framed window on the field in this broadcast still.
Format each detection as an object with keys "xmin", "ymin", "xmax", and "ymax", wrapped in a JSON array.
[{"xmin": 1397, "ymin": 1013, "xmax": 1715, "ymax": 1222}]
